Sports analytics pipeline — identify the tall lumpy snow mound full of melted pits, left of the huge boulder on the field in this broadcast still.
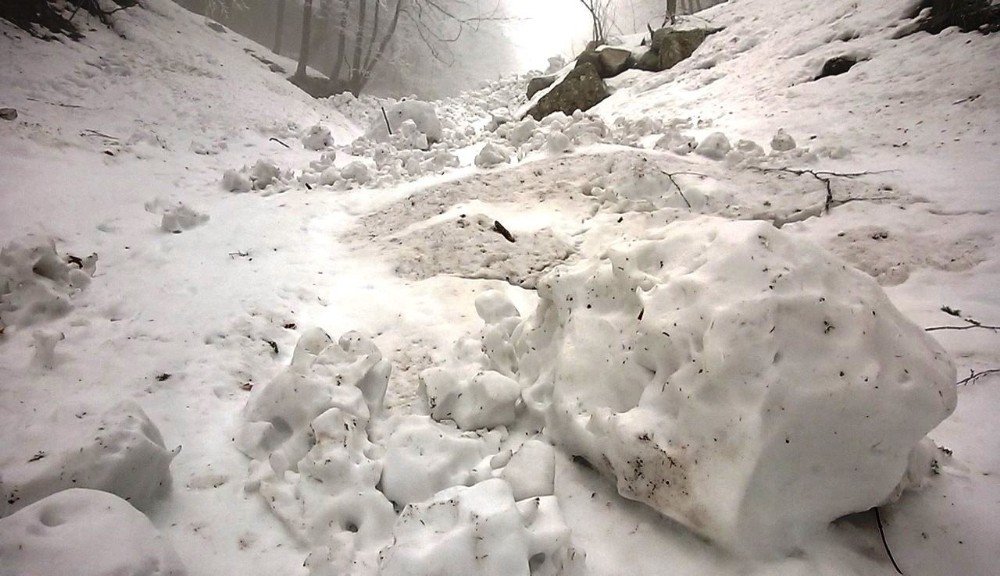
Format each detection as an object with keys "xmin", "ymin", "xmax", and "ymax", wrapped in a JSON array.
[{"xmin": 236, "ymin": 329, "xmax": 395, "ymax": 573}]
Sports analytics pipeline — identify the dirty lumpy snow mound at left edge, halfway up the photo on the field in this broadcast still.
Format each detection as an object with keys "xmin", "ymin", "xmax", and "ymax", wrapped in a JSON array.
[{"xmin": 0, "ymin": 236, "xmax": 97, "ymax": 333}]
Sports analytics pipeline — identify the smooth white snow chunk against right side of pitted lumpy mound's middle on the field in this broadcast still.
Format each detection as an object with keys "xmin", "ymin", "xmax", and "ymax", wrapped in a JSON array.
[{"xmin": 381, "ymin": 415, "xmax": 501, "ymax": 506}]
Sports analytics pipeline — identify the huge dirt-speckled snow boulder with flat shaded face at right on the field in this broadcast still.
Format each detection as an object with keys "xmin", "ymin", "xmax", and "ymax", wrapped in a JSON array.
[{"xmin": 513, "ymin": 218, "xmax": 956, "ymax": 554}]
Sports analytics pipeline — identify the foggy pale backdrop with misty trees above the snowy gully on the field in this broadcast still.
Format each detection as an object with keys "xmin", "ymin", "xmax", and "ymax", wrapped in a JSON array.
[{"xmin": 178, "ymin": 0, "xmax": 724, "ymax": 98}]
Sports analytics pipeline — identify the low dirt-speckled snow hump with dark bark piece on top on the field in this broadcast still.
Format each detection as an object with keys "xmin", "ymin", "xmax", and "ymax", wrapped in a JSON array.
[{"xmin": 382, "ymin": 214, "xmax": 573, "ymax": 287}]
